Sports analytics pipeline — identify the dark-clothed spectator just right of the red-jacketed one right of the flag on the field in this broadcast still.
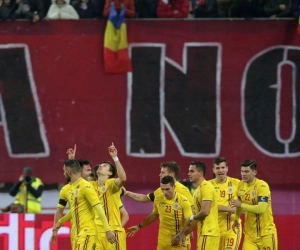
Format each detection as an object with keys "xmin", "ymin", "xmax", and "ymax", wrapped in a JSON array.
[{"xmin": 191, "ymin": 0, "xmax": 218, "ymax": 18}]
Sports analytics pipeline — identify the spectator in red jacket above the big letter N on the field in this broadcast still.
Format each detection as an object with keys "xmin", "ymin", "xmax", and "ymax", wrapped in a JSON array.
[{"xmin": 156, "ymin": 0, "xmax": 190, "ymax": 18}]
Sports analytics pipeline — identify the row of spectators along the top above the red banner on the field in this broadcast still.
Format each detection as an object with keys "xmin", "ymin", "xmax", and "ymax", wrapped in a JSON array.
[{"xmin": 0, "ymin": 0, "xmax": 300, "ymax": 22}]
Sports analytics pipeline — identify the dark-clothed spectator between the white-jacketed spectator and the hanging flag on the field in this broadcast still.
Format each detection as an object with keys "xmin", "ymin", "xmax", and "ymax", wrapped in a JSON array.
[{"xmin": 72, "ymin": 0, "xmax": 103, "ymax": 19}]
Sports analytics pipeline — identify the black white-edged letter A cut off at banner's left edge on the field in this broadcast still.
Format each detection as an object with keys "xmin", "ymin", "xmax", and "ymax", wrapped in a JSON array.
[{"xmin": 0, "ymin": 44, "xmax": 50, "ymax": 158}]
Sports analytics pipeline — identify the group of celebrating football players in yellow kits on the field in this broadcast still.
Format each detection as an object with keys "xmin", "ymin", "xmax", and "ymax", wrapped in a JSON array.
[{"xmin": 51, "ymin": 144, "xmax": 278, "ymax": 250}]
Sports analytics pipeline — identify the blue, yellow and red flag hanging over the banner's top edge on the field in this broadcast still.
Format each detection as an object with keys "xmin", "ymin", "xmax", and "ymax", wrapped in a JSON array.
[{"xmin": 104, "ymin": 2, "xmax": 132, "ymax": 74}]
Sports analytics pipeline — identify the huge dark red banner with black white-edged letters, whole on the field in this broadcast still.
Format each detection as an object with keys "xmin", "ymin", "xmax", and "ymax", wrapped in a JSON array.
[{"xmin": 0, "ymin": 20, "xmax": 300, "ymax": 186}]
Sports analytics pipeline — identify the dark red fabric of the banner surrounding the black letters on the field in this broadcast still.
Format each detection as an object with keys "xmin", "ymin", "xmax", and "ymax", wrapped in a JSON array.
[{"xmin": 0, "ymin": 20, "xmax": 300, "ymax": 188}]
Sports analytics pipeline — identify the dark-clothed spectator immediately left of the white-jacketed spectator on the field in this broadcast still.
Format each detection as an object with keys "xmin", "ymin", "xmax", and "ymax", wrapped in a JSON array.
[{"xmin": 12, "ymin": 0, "xmax": 45, "ymax": 23}]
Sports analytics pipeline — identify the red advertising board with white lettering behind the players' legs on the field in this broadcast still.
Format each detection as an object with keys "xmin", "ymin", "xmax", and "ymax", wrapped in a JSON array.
[{"xmin": 0, "ymin": 214, "xmax": 300, "ymax": 250}]
